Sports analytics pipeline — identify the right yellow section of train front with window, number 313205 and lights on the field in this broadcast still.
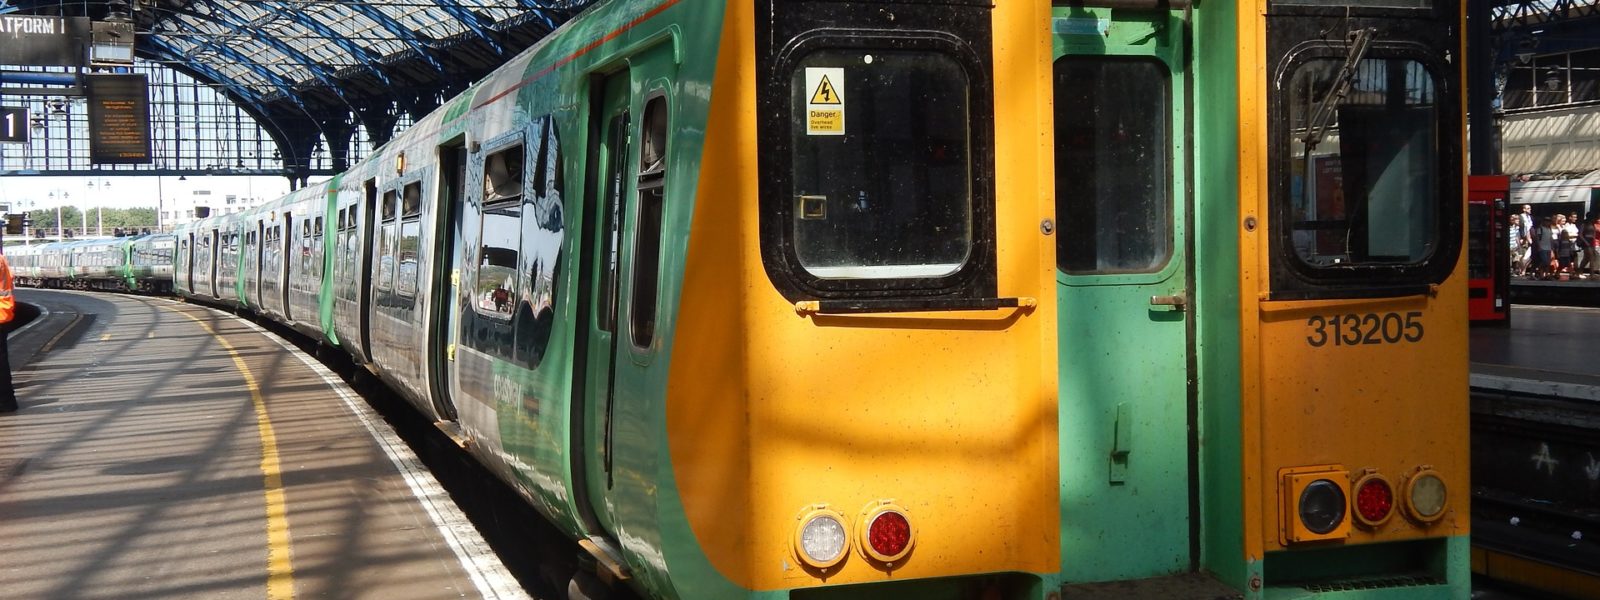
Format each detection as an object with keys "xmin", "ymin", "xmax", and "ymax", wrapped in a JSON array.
[{"xmin": 1222, "ymin": 0, "xmax": 1470, "ymax": 598}]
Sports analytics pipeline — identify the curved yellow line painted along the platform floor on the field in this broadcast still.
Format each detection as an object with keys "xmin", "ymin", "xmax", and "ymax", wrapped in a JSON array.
[{"xmin": 162, "ymin": 307, "xmax": 294, "ymax": 600}]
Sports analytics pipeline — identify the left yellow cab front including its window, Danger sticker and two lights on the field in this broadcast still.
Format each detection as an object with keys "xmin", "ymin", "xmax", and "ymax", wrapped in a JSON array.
[{"xmin": 611, "ymin": 0, "xmax": 1059, "ymax": 600}]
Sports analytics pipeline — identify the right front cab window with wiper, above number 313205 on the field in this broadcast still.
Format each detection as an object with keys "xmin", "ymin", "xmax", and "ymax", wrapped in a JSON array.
[{"xmin": 1278, "ymin": 56, "xmax": 1456, "ymax": 270}]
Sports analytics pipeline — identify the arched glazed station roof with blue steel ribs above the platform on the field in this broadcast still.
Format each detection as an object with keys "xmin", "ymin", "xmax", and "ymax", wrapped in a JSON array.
[{"xmin": 10, "ymin": 0, "xmax": 595, "ymax": 175}]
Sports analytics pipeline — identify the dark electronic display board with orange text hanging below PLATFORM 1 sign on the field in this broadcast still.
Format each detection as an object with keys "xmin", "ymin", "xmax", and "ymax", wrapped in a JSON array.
[{"xmin": 88, "ymin": 74, "xmax": 152, "ymax": 165}]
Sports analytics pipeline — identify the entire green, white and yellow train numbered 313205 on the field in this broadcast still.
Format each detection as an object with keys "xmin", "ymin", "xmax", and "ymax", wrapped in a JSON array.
[{"xmin": 162, "ymin": 0, "xmax": 1469, "ymax": 600}]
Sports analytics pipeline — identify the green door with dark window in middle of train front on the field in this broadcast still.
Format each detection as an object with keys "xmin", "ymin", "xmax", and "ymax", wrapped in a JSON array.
[{"xmin": 1051, "ymin": 6, "xmax": 1194, "ymax": 582}]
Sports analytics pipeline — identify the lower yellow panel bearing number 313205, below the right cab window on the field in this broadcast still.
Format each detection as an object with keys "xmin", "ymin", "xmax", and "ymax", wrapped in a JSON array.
[{"xmin": 1259, "ymin": 289, "xmax": 1469, "ymax": 550}]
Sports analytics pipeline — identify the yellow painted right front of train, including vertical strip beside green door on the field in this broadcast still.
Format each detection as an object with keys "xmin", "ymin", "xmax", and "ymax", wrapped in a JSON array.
[{"xmin": 1238, "ymin": 0, "xmax": 1470, "ymax": 560}]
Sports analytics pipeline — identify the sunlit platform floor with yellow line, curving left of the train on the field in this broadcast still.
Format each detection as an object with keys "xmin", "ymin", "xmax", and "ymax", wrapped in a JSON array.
[{"xmin": 0, "ymin": 290, "xmax": 526, "ymax": 600}]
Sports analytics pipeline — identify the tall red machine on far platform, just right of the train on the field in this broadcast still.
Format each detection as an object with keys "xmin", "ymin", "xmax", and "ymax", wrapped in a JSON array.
[{"xmin": 1467, "ymin": 174, "xmax": 1512, "ymax": 323}]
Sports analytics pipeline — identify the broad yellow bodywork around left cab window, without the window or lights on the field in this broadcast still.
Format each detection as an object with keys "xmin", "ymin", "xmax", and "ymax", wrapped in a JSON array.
[{"xmin": 666, "ymin": 3, "xmax": 1059, "ymax": 590}]
